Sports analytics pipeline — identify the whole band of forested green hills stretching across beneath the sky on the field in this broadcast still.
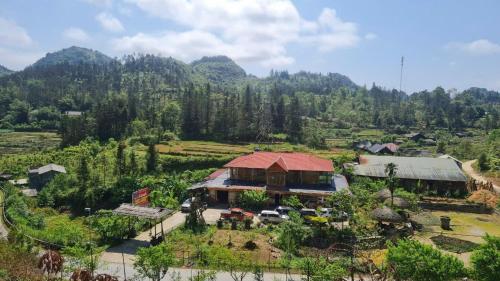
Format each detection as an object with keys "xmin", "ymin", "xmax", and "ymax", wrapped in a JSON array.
[{"xmin": 0, "ymin": 47, "xmax": 500, "ymax": 147}]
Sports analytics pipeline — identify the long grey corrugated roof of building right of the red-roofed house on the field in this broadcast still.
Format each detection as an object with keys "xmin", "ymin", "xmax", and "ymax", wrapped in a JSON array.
[{"xmin": 354, "ymin": 155, "xmax": 467, "ymax": 182}]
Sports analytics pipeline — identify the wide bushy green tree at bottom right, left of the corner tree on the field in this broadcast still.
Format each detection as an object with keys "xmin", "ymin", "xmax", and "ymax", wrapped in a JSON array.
[{"xmin": 387, "ymin": 239, "xmax": 466, "ymax": 281}]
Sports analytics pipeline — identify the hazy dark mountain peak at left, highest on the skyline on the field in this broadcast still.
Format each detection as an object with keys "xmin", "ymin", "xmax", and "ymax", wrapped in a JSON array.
[{"xmin": 33, "ymin": 46, "xmax": 113, "ymax": 68}]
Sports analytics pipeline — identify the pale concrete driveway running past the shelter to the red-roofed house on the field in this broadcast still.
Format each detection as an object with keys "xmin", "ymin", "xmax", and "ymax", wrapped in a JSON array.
[{"xmin": 101, "ymin": 208, "xmax": 222, "ymax": 264}]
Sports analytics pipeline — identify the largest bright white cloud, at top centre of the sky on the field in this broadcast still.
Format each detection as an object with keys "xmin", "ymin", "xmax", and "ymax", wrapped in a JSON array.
[{"xmin": 112, "ymin": 0, "xmax": 360, "ymax": 67}]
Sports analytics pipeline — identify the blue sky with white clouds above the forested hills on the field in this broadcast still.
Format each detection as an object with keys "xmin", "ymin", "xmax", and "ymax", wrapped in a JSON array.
[{"xmin": 0, "ymin": 0, "xmax": 500, "ymax": 93}]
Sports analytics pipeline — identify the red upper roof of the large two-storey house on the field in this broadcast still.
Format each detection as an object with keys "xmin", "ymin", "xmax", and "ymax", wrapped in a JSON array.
[{"xmin": 224, "ymin": 152, "xmax": 333, "ymax": 172}]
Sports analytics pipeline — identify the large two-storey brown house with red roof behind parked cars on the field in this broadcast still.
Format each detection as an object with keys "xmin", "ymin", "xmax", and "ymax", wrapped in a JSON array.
[{"xmin": 201, "ymin": 152, "xmax": 347, "ymax": 204}]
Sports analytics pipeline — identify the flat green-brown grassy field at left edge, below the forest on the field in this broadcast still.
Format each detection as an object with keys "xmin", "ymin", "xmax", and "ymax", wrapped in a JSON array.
[{"xmin": 0, "ymin": 131, "xmax": 61, "ymax": 154}]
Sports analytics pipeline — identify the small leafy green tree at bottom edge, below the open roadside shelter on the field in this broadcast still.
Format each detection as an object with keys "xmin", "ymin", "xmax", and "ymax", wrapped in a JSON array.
[{"xmin": 134, "ymin": 243, "xmax": 175, "ymax": 281}]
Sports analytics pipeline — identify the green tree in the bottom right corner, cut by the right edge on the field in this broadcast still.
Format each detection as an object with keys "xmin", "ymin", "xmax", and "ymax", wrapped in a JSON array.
[{"xmin": 471, "ymin": 235, "xmax": 500, "ymax": 281}]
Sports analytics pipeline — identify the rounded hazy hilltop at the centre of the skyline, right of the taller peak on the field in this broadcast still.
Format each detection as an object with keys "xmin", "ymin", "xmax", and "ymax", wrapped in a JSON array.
[{"xmin": 190, "ymin": 56, "xmax": 247, "ymax": 84}]
